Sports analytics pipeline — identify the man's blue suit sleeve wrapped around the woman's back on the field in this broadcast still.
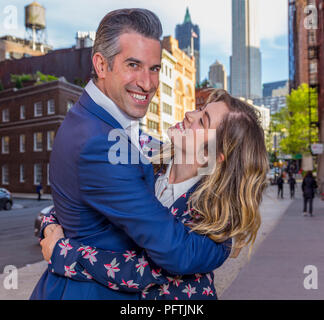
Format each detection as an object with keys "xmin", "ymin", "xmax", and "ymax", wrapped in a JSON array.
[{"xmin": 79, "ymin": 136, "xmax": 230, "ymax": 274}]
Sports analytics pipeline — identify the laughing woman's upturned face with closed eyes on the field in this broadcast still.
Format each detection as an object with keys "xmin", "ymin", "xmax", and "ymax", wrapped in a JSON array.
[{"xmin": 168, "ymin": 101, "xmax": 229, "ymax": 165}]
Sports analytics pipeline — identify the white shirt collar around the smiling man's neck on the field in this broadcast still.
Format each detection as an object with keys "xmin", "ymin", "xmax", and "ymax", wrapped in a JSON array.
[{"xmin": 84, "ymin": 80, "xmax": 139, "ymax": 129}]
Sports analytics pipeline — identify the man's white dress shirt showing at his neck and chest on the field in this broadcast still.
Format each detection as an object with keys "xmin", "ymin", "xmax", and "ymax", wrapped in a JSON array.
[{"xmin": 84, "ymin": 80, "xmax": 140, "ymax": 150}]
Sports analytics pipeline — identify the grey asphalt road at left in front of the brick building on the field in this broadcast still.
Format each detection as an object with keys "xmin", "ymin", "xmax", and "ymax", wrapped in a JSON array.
[{"xmin": 0, "ymin": 199, "xmax": 52, "ymax": 273}]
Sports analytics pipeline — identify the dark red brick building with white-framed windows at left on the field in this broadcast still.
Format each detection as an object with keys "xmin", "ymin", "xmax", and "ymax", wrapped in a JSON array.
[{"xmin": 0, "ymin": 79, "xmax": 82, "ymax": 193}]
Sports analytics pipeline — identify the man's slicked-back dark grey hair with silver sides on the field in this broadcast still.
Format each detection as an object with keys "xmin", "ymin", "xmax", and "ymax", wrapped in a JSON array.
[{"xmin": 92, "ymin": 8, "xmax": 163, "ymax": 79}]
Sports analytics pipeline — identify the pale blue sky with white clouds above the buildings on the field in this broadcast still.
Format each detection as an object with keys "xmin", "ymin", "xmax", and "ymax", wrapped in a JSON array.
[{"xmin": 0, "ymin": 0, "xmax": 288, "ymax": 83}]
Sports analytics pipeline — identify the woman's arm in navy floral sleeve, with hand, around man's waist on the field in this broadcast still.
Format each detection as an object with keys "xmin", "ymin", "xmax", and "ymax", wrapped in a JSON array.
[{"xmin": 41, "ymin": 225, "xmax": 168, "ymax": 292}]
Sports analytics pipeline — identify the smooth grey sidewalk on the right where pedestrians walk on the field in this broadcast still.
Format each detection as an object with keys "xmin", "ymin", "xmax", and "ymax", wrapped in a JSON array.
[{"xmin": 220, "ymin": 188, "xmax": 324, "ymax": 300}]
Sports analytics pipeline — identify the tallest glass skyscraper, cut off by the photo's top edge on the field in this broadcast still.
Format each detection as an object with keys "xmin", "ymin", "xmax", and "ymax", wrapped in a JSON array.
[{"xmin": 231, "ymin": 0, "xmax": 262, "ymax": 99}]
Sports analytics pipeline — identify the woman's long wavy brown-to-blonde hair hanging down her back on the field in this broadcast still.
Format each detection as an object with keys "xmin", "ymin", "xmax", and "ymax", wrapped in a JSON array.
[{"xmin": 188, "ymin": 89, "xmax": 268, "ymax": 254}]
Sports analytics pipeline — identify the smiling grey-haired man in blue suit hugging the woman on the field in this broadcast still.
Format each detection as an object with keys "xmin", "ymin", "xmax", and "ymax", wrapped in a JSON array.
[{"xmin": 31, "ymin": 9, "xmax": 229, "ymax": 300}]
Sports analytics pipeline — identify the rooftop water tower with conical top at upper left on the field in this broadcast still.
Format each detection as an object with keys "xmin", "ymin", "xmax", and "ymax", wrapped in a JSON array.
[{"xmin": 25, "ymin": 1, "xmax": 46, "ymax": 50}]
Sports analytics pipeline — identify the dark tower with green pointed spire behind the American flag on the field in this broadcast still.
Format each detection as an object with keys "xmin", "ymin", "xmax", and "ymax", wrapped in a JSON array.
[{"xmin": 175, "ymin": 7, "xmax": 200, "ymax": 85}]
